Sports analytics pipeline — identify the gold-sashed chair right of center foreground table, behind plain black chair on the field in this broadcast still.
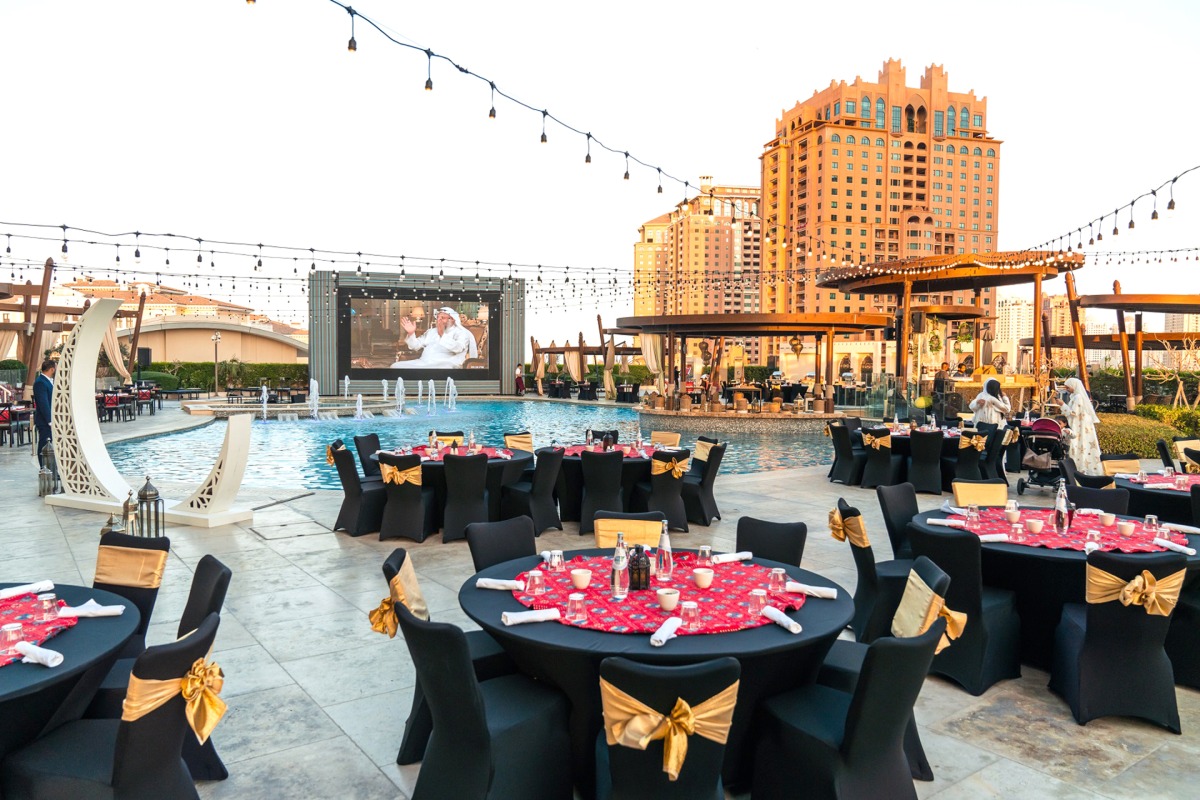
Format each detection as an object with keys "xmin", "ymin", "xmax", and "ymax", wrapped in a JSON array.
[{"xmin": 817, "ymin": 557, "xmax": 950, "ymax": 781}]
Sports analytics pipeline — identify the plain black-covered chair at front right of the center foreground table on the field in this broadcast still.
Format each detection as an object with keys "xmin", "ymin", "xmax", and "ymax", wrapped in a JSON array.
[{"xmin": 751, "ymin": 619, "xmax": 946, "ymax": 800}]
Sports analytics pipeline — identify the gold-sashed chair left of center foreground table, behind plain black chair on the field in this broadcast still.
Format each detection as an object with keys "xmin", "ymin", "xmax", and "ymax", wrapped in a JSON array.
[{"xmin": 379, "ymin": 547, "xmax": 516, "ymax": 766}]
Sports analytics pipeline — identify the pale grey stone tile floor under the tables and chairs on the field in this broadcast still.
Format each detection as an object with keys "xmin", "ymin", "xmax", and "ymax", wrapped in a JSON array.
[{"xmin": 0, "ymin": 405, "xmax": 1200, "ymax": 800}]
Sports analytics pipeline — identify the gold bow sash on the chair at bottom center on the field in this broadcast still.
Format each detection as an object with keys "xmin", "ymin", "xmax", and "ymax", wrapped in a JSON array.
[{"xmin": 600, "ymin": 678, "xmax": 740, "ymax": 781}]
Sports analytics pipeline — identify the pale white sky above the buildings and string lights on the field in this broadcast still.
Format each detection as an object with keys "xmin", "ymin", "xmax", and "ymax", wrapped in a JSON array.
[{"xmin": 0, "ymin": 0, "xmax": 1200, "ymax": 352}]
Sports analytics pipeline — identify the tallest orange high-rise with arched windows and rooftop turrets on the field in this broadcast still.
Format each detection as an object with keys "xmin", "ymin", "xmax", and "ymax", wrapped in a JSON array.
[{"xmin": 762, "ymin": 59, "xmax": 1001, "ymax": 353}]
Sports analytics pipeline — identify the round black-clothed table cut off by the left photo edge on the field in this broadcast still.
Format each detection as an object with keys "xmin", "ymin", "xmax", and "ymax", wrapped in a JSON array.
[{"xmin": 0, "ymin": 583, "xmax": 140, "ymax": 758}]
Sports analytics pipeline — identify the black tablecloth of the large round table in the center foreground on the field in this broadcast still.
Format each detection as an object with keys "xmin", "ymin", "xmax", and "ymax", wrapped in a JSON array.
[{"xmin": 458, "ymin": 549, "xmax": 854, "ymax": 798}]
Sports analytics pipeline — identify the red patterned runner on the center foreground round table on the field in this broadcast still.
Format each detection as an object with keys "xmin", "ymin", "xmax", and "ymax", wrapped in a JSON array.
[{"xmin": 512, "ymin": 553, "xmax": 805, "ymax": 636}]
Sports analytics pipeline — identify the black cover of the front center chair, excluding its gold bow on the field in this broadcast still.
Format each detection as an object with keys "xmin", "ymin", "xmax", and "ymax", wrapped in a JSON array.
[{"xmin": 596, "ymin": 657, "xmax": 742, "ymax": 800}]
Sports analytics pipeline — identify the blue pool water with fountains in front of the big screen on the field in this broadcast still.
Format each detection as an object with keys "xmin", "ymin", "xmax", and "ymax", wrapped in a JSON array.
[{"xmin": 108, "ymin": 401, "xmax": 829, "ymax": 489}]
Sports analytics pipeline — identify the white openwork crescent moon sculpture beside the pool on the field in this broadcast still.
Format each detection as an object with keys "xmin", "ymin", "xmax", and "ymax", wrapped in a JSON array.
[{"xmin": 46, "ymin": 300, "xmax": 254, "ymax": 528}]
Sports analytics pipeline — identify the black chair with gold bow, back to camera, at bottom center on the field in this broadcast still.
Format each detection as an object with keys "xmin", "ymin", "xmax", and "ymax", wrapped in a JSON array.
[{"xmin": 595, "ymin": 656, "xmax": 742, "ymax": 800}]
